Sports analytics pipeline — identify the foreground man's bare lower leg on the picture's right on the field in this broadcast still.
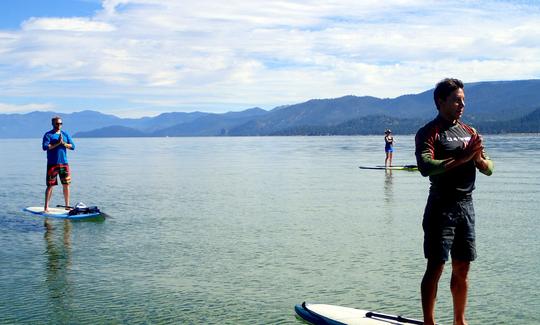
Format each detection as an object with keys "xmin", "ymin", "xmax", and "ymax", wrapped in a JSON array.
[{"xmin": 450, "ymin": 260, "xmax": 470, "ymax": 325}]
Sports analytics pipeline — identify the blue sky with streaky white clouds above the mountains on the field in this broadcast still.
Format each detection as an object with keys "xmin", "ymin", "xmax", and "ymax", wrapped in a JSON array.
[{"xmin": 0, "ymin": 0, "xmax": 540, "ymax": 117}]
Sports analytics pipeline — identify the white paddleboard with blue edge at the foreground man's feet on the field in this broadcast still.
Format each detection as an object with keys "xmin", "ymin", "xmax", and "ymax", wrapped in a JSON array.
[{"xmin": 294, "ymin": 302, "xmax": 424, "ymax": 325}]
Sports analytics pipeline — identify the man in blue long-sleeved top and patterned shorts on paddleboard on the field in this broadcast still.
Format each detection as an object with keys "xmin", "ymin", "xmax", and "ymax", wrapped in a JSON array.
[{"xmin": 42, "ymin": 116, "xmax": 75, "ymax": 212}]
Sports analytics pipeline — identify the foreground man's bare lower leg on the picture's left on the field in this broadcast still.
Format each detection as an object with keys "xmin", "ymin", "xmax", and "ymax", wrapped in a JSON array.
[{"xmin": 421, "ymin": 259, "xmax": 444, "ymax": 325}]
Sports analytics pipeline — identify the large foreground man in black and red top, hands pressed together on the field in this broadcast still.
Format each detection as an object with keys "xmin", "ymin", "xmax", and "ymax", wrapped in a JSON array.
[{"xmin": 415, "ymin": 79, "xmax": 493, "ymax": 325}]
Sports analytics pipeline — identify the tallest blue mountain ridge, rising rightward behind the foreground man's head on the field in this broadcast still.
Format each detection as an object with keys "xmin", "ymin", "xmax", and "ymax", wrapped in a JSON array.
[{"xmin": 229, "ymin": 80, "xmax": 540, "ymax": 136}]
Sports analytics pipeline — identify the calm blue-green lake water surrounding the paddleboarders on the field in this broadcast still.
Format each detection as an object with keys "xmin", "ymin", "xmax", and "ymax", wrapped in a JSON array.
[{"xmin": 0, "ymin": 135, "xmax": 540, "ymax": 325}]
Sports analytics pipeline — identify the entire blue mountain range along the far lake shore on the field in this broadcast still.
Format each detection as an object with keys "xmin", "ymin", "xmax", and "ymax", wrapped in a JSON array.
[{"xmin": 0, "ymin": 79, "xmax": 540, "ymax": 138}]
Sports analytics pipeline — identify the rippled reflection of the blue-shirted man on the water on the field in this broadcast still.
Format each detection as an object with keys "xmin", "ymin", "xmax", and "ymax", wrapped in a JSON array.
[{"xmin": 44, "ymin": 219, "xmax": 72, "ymax": 318}]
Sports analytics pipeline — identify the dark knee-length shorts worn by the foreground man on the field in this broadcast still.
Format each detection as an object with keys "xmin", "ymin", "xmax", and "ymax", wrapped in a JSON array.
[{"xmin": 422, "ymin": 193, "xmax": 476, "ymax": 261}]
